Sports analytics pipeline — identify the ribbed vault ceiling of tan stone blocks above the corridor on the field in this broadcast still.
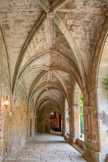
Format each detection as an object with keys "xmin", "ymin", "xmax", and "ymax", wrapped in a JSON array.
[{"xmin": 0, "ymin": 0, "xmax": 108, "ymax": 114}]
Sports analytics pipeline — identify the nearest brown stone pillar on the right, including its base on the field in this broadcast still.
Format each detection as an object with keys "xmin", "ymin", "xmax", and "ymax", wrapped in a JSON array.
[{"xmin": 83, "ymin": 105, "xmax": 106, "ymax": 162}]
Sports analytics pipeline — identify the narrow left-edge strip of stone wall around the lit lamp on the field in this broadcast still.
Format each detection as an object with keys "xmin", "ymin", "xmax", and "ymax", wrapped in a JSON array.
[{"xmin": 0, "ymin": 28, "xmax": 10, "ymax": 158}]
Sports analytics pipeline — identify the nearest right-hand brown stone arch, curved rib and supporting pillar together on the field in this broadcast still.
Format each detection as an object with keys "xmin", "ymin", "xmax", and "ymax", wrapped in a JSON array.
[{"xmin": 84, "ymin": 16, "xmax": 108, "ymax": 161}]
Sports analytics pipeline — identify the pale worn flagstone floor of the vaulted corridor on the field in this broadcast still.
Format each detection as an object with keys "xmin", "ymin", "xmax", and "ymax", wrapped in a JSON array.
[{"xmin": 5, "ymin": 134, "xmax": 86, "ymax": 162}]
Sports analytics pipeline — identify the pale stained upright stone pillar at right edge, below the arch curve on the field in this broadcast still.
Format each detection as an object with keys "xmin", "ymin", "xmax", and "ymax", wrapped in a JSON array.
[{"xmin": 97, "ymin": 85, "xmax": 108, "ymax": 153}]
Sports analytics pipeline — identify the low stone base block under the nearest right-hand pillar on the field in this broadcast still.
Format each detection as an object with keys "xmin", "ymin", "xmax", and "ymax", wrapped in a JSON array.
[{"xmin": 83, "ymin": 144, "xmax": 106, "ymax": 162}]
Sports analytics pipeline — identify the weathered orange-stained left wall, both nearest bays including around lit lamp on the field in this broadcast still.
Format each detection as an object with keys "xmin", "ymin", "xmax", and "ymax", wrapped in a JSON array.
[{"xmin": 0, "ymin": 31, "xmax": 30, "ymax": 158}]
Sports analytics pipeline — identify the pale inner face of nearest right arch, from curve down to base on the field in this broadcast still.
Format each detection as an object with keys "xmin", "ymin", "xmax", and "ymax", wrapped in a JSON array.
[{"xmin": 96, "ymin": 31, "xmax": 108, "ymax": 152}]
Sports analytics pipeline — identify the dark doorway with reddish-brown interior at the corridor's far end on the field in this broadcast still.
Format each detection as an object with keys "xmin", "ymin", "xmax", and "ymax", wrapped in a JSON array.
[{"xmin": 50, "ymin": 112, "xmax": 61, "ymax": 132}]
